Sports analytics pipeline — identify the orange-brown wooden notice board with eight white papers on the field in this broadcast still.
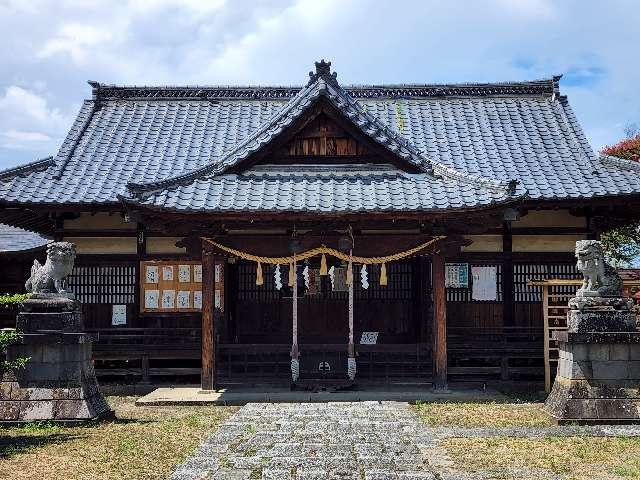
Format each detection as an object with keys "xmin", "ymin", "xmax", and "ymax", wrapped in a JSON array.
[{"xmin": 140, "ymin": 260, "xmax": 202, "ymax": 313}]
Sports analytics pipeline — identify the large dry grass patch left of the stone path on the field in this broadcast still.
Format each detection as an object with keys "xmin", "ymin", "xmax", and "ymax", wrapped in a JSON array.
[{"xmin": 0, "ymin": 397, "xmax": 237, "ymax": 480}]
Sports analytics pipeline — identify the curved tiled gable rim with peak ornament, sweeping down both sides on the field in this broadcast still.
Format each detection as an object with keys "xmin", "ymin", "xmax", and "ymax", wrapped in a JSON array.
[{"xmin": 128, "ymin": 60, "xmax": 514, "ymax": 196}]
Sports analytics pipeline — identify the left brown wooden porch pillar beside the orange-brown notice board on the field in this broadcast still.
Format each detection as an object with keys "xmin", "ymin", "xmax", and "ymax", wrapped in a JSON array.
[{"xmin": 200, "ymin": 245, "xmax": 216, "ymax": 390}]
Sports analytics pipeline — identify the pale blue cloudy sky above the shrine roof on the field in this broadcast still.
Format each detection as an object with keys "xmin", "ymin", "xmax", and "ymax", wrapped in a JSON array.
[{"xmin": 0, "ymin": 0, "xmax": 640, "ymax": 169}]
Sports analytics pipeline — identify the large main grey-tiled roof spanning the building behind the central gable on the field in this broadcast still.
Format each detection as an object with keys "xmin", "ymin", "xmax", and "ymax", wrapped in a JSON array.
[{"xmin": 0, "ymin": 58, "xmax": 640, "ymax": 212}]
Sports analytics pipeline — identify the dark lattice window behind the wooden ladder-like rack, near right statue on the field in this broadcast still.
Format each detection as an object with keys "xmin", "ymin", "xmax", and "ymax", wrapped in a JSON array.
[{"xmin": 513, "ymin": 263, "xmax": 580, "ymax": 302}]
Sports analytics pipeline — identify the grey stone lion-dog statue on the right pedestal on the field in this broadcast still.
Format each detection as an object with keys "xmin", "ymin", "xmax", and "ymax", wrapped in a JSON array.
[{"xmin": 576, "ymin": 240, "xmax": 622, "ymax": 297}]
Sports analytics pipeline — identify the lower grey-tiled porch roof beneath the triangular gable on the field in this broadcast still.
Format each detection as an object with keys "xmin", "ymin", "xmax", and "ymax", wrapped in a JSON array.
[{"xmin": 131, "ymin": 165, "xmax": 524, "ymax": 213}]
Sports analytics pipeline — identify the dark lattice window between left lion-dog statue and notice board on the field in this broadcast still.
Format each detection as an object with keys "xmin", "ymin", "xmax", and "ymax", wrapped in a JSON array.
[{"xmin": 69, "ymin": 265, "xmax": 136, "ymax": 305}]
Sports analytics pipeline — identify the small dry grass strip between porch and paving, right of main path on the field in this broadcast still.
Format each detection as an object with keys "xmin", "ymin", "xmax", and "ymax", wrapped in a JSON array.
[{"xmin": 415, "ymin": 402, "xmax": 552, "ymax": 427}]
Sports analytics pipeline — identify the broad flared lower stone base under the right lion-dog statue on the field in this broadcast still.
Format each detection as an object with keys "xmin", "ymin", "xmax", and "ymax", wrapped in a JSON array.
[{"xmin": 545, "ymin": 332, "xmax": 640, "ymax": 423}]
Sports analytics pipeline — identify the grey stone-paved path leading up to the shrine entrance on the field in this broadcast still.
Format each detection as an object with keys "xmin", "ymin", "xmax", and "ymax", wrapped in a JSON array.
[{"xmin": 171, "ymin": 402, "xmax": 441, "ymax": 480}]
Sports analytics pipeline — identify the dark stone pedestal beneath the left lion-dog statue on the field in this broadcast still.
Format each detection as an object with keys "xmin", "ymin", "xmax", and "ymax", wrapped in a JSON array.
[{"xmin": 0, "ymin": 299, "xmax": 113, "ymax": 422}]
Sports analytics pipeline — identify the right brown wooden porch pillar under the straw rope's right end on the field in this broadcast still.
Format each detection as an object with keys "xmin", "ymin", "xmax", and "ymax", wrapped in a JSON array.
[{"xmin": 431, "ymin": 252, "xmax": 447, "ymax": 390}]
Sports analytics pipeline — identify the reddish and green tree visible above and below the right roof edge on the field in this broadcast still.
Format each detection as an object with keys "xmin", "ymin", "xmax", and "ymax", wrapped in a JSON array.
[{"xmin": 600, "ymin": 129, "xmax": 640, "ymax": 266}]
